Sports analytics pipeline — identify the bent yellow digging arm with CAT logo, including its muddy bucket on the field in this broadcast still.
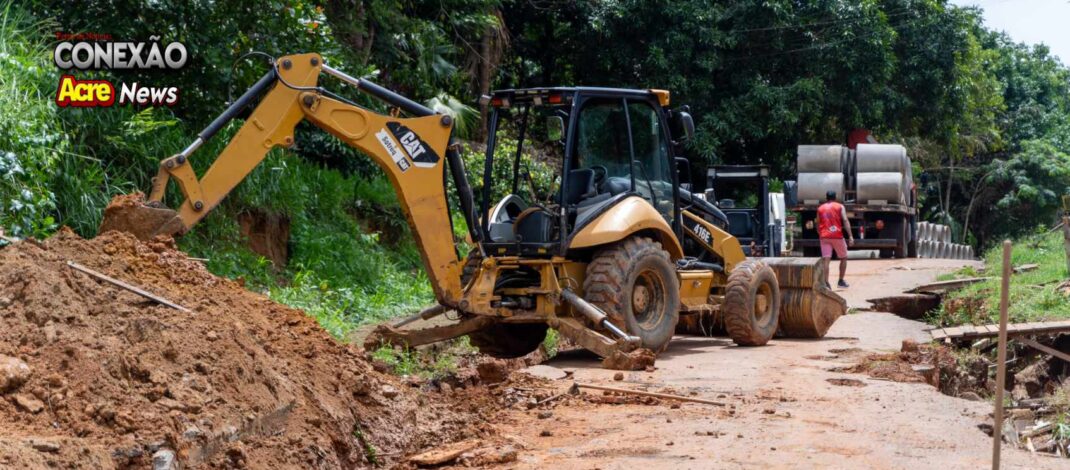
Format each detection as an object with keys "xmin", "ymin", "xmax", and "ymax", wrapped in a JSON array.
[{"xmin": 101, "ymin": 54, "xmax": 483, "ymax": 307}]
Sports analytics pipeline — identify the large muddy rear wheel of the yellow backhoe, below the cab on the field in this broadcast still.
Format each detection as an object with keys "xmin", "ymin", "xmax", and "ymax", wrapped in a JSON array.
[{"xmin": 583, "ymin": 237, "xmax": 679, "ymax": 352}]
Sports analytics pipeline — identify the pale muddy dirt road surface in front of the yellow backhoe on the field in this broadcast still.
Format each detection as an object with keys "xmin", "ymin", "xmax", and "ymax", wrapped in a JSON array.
[{"xmin": 502, "ymin": 259, "xmax": 1066, "ymax": 469}]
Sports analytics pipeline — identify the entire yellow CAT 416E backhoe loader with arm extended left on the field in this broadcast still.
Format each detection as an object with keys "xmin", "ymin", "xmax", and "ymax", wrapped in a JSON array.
[{"xmin": 102, "ymin": 54, "xmax": 845, "ymax": 368}]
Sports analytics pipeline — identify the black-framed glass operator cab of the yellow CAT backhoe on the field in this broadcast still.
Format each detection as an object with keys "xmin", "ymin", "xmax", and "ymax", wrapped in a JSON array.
[{"xmin": 474, "ymin": 87, "xmax": 693, "ymax": 256}]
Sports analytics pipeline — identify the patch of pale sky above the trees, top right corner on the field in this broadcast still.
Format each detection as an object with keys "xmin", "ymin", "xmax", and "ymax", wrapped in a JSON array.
[{"xmin": 951, "ymin": 0, "xmax": 1070, "ymax": 65}]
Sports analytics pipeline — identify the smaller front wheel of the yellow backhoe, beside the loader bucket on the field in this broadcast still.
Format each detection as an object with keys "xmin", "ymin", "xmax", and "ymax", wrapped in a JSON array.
[{"xmin": 721, "ymin": 259, "xmax": 780, "ymax": 346}]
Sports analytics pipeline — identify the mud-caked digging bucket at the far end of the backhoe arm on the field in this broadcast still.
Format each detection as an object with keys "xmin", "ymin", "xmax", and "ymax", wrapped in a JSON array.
[{"xmin": 98, "ymin": 193, "xmax": 185, "ymax": 241}]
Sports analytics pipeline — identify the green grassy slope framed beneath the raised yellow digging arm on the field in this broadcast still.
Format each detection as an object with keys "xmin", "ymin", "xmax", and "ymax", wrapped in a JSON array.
[{"xmin": 180, "ymin": 152, "xmax": 433, "ymax": 338}]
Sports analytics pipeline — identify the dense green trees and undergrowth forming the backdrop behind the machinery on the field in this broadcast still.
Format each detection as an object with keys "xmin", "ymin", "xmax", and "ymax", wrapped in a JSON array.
[{"xmin": 6, "ymin": 0, "xmax": 1070, "ymax": 337}]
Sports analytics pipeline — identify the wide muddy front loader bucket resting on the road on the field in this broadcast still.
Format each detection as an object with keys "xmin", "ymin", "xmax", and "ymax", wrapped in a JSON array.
[{"xmin": 762, "ymin": 258, "xmax": 847, "ymax": 338}]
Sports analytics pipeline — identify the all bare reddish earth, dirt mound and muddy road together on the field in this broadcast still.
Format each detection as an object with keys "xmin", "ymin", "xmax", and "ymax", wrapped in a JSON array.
[{"xmin": 0, "ymin": 231, "xmax": 1065, "ymax": 469}]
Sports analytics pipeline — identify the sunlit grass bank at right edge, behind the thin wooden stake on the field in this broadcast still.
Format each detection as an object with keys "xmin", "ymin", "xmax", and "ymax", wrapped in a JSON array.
[{"xmin": 930, "ymin": 232, "xmax": 1070, "ymax": 327}]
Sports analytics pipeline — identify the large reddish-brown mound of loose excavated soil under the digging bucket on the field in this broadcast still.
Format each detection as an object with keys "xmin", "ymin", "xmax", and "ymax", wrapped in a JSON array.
[{"xmin": 0, "ymin": 230, "xmax": 493, "ymax": 469}]
